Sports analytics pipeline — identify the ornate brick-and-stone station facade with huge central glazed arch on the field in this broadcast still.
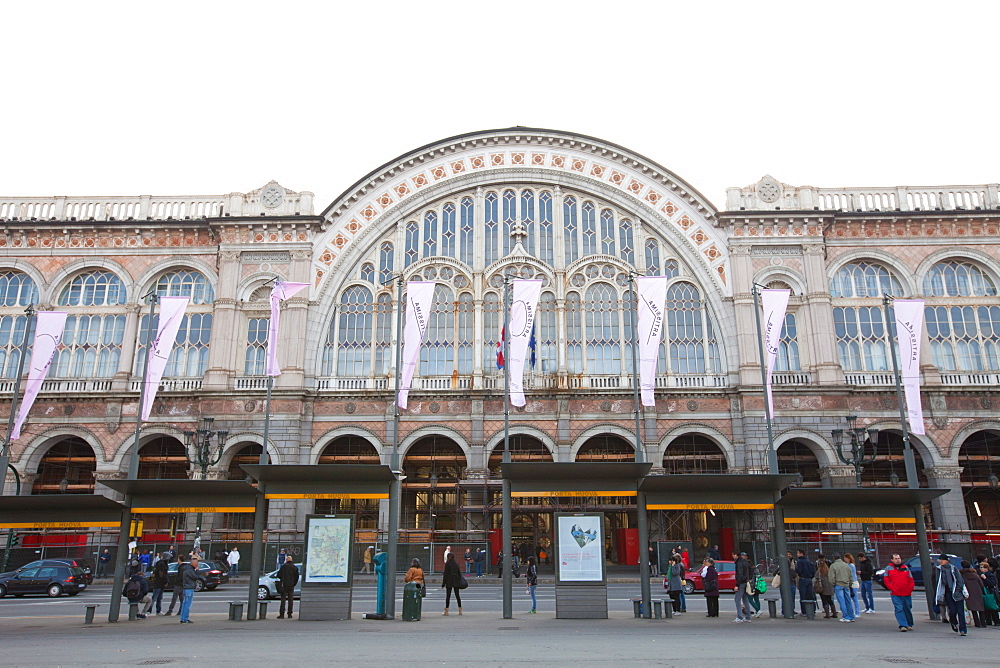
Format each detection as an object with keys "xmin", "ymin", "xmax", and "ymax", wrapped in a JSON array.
[{"xmin": 0, "ymin": 127, "xmax": 1000, "ymax": 554}]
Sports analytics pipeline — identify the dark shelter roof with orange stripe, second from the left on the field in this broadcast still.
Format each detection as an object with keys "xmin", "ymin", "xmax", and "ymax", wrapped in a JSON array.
[{"xmin": 98, "ymin": 480, "xmax": 259, "ymax": 513}]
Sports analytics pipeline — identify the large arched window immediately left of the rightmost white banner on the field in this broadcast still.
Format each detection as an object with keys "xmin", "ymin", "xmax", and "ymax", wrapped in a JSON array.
[{"xmin": 830, "ymin": 262, "xmax": 903, "ymax": 371}]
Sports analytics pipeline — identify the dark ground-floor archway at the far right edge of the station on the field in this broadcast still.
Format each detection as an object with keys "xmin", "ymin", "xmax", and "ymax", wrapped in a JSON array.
[{"xmin": 958, "ymin": 431, "xmax": 1000, "ymax": 532}]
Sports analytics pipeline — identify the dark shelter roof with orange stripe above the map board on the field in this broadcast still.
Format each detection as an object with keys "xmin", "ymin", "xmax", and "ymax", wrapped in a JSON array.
[{"xmin": 241, "ymin": 464, "xmax": 396, "ymax": 499}]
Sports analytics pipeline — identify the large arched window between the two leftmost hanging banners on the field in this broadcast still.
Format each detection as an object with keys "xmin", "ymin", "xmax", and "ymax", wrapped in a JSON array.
[{"xmin": 52, "ymin": 271, "xmax": 125, "ymax": 378}]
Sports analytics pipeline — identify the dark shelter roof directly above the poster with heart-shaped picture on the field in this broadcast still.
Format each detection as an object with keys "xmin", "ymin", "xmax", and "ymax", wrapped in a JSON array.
[{"xmin": 500, "ymin": 462, "xmax": 653, "ymax": 496}]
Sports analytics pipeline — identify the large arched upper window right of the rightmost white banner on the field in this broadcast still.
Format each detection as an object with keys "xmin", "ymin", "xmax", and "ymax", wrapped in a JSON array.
[{"xmin": 923, "ymin": 260, "xmax": 1000, "ymax": 371}]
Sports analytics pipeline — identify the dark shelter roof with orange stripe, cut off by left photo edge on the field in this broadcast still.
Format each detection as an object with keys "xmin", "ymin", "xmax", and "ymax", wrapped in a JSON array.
[{"xmin": 0, "ymin": 494, "xmax": 124, "ymax": 529}]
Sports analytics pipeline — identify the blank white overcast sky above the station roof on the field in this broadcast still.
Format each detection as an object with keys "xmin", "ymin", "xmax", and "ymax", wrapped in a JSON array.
[{"xmin": 0, "ymin": 0, "xmax": 1000, "ymax": 212}]
